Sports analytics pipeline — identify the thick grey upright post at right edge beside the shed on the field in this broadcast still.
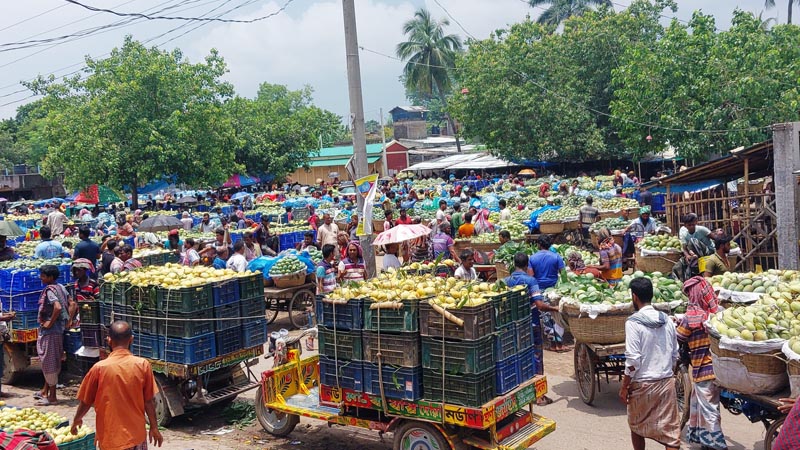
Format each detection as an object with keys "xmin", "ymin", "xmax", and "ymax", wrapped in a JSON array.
[{"xmin": 772, "ymin": 122, "xmax": 800, "ymax": 270}]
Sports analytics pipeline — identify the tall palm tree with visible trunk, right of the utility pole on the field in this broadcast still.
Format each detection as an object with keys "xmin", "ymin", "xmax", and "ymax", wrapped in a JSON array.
[{"xmin": 397, "ymin": 8, "xmax": 463, "ymax": 152}]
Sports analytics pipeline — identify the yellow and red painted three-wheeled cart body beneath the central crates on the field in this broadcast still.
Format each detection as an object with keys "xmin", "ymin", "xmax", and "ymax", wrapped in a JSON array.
[{"xmin": 256, "ymin": 350, "xmax": 556, "ymax": 450}]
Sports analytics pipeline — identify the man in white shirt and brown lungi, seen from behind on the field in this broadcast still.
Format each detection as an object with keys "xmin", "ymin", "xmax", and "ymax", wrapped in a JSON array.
[{"xmin": 619, "ymin": 277, "xmax": 681, "ymax": 450}]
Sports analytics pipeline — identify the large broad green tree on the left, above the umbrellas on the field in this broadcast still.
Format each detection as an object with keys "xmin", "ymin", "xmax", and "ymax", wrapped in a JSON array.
[{"xmin": 29, "ymin": 37, "xmax": 240, "ymax": 206}]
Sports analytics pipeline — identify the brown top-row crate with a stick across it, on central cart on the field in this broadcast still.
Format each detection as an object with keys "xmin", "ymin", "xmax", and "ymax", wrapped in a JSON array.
[{"xmin": 419, "ymin": 301, "xmax": 494, "ymax": 340}]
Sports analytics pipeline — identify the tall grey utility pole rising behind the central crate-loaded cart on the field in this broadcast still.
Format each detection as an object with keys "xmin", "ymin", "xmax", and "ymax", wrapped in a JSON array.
[{"xmin": 342, "ymin": 0, "xmax": 376, "ymax": 277}]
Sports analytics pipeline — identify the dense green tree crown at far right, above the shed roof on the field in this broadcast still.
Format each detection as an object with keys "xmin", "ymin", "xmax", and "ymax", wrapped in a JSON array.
[{"xmin": 611, "ymin": 10, "xmax": 800, "ymax": 160}]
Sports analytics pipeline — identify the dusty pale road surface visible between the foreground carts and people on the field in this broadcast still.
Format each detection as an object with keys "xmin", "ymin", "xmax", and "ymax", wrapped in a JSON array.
[{"xmin": 3, "ymin": 317, "xmax": 776, "ymax": 450}]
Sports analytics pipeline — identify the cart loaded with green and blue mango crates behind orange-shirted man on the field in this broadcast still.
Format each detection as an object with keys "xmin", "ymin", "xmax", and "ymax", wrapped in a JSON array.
[{"xmin": 94, "ymin": 264, "xmax": 267, "ymax": 426}]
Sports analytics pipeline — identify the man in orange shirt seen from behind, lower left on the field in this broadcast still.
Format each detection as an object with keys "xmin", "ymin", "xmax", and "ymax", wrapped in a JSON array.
[{"xmin": 72, "ymin": 320, "xmax": 164, "ymax": 450}]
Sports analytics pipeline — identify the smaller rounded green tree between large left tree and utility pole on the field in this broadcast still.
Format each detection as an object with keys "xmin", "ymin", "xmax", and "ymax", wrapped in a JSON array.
[{"xmin": 226, "ymin": 83, "xmax": 345, "ymax": 183}]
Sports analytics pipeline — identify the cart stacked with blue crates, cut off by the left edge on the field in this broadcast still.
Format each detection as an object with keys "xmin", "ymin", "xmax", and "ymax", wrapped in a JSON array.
[{"xmin": 0, "ymin": 258, "xmax": 75, "ymax": 384}]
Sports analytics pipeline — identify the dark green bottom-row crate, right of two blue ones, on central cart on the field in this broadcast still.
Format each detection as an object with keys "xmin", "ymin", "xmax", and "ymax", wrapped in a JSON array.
[{"xmin": 422, "ymin": 367, "xmax": 495, "ymax": 408}]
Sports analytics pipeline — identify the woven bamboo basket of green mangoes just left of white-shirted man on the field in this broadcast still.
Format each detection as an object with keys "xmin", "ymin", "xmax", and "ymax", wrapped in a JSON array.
[{"xmin": 561, "ymin": 304, "xmax": 631, "ymax": 344}]
